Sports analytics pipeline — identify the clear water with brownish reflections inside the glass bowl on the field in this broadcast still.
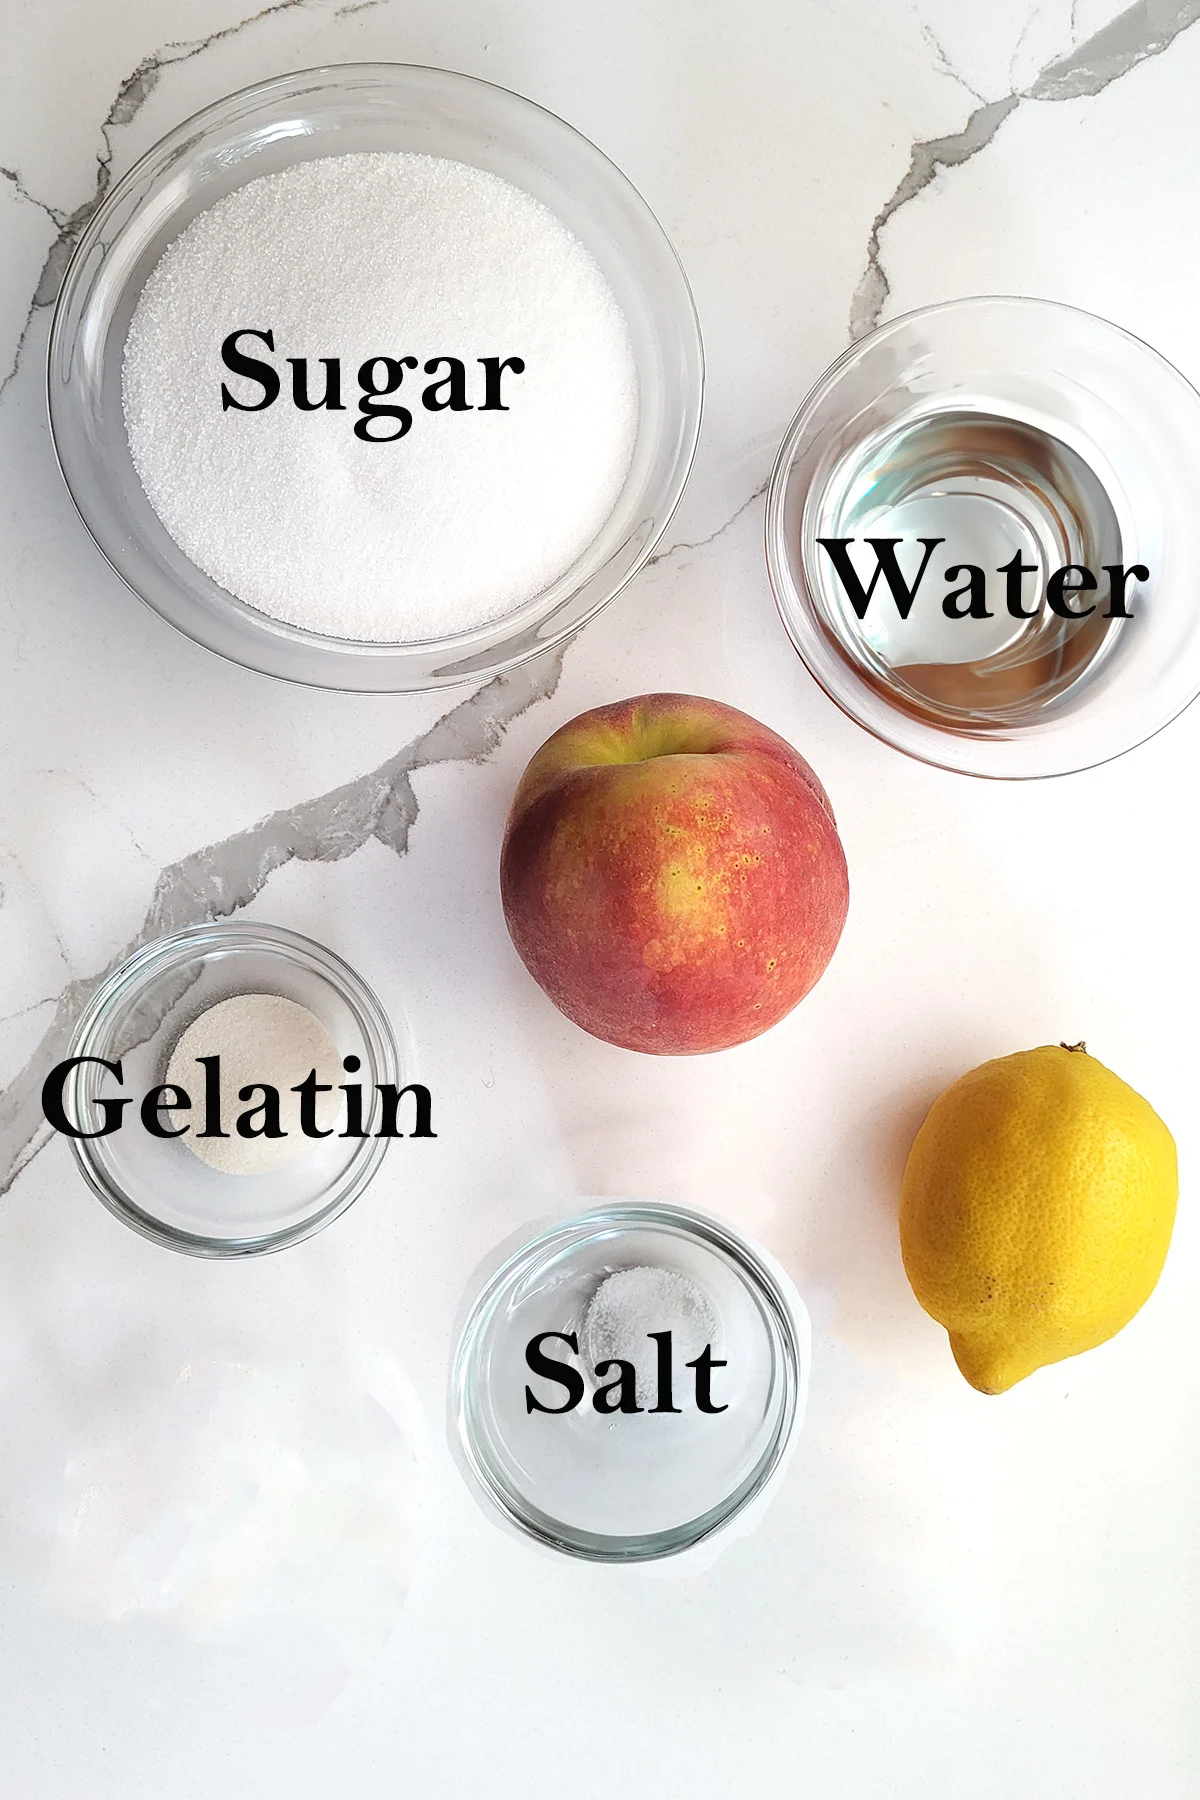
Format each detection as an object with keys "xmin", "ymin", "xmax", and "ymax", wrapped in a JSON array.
[{"xmin": 810, "ymin": 407, "xmax": 1137, "ymax": 729}]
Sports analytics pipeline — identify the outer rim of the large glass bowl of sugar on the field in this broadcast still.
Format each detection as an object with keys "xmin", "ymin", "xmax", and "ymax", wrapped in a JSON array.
[{"xmin": 43, "ymin": 61, "xmax": 705, "ymax": 693}]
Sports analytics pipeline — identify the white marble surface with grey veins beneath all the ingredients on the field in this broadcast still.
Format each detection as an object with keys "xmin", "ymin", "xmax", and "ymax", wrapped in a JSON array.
[{"xmin": 0, "ymin": 0, "xmax": 1200, "ymax": 1800}]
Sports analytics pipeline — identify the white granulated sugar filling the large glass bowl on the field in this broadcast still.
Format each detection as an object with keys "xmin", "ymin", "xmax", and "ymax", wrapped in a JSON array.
[{"xmin": 124, "ymin": 153, "xmax": 637, "ymax": 643}]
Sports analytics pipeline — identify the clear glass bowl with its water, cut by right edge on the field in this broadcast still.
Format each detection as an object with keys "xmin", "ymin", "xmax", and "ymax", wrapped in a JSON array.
[{"xmin": 766, "ymin": 297, "xmax": 1200, "ymax": 778}]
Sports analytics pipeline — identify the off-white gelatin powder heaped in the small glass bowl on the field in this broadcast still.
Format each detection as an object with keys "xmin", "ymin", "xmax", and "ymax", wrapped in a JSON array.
[{"xmin": 164, "ymin": 994, "xmax": 342, "ymax": 1175}]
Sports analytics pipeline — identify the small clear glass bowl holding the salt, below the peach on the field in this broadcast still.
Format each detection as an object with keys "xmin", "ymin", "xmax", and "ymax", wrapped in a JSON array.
[{"xmin": 450, "ymin": 1201, "xmax": 810, "ymax": 1562}]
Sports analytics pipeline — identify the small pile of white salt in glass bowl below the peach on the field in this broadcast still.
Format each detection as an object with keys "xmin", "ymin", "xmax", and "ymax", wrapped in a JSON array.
[{"xmin": 579, "ymin": 1265, "xmax": 718, "ymax": 1404}]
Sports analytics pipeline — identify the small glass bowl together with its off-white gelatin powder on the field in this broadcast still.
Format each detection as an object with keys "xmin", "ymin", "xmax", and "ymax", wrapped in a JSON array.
[{"xmin": 61, "ymin": 920, "xmax": 399, "ymax": 1256}]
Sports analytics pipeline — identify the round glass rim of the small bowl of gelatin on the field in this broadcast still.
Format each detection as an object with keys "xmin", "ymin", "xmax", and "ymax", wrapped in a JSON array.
[{"xmin": 65, "ymin": 918, "xmax": 407, "ymax": 1262}]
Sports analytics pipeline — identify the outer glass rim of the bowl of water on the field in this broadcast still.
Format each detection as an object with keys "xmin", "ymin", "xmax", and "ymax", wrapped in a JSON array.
[{"xmin": 763, "ymin": 293, "xmax": 1200, "ymax": 781}]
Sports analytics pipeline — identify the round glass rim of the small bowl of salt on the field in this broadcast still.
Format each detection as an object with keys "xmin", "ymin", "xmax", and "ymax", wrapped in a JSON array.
[{"xmin": 448, "ymin": 1199, "xmax": 811, "ymax": 1564}]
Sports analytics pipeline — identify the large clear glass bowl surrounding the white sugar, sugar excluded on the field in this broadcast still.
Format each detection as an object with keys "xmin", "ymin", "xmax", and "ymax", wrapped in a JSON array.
[{"xmin": 49, "ymin": 63, "xmax": 703, "ymax": 693}]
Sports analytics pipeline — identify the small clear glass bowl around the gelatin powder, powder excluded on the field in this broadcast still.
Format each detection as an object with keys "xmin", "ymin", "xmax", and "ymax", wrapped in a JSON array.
[{"xmin": 63, "ymin": 920, "xmax": 399, "ymax": 1256}]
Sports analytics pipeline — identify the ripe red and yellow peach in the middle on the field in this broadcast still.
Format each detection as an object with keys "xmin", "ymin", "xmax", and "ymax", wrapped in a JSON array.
[{"xmin": 500, "ymin": 693, "xmax": 849, "ymax": 1057}]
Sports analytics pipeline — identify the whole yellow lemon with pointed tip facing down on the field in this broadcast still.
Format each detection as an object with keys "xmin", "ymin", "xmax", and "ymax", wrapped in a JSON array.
[{"xmin": 900, "ymin": 1044, "xmax": 1178, "ymax": 1393}]
